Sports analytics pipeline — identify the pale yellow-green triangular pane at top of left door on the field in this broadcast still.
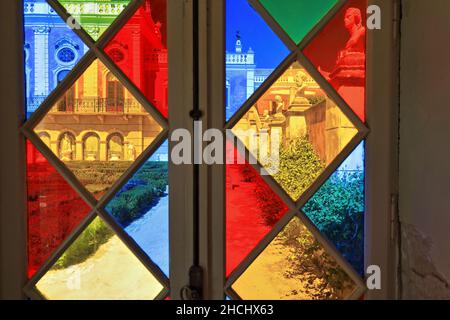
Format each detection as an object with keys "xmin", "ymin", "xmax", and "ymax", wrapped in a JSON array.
[{"xmin": 58, "ymin": 0, "xmax": 130, "ymax": 40}]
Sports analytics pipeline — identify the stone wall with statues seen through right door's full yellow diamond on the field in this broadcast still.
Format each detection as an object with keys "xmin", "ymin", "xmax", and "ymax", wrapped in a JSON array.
[{"xmin": 233, "ymin": 63, "xmax": 357, "ymax": 164}]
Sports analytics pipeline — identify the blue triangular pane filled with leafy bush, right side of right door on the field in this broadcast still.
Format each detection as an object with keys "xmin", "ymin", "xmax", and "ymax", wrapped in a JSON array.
[{"xmin": 303, "ymin": 142, "xmax": 365, "ymax": 275}]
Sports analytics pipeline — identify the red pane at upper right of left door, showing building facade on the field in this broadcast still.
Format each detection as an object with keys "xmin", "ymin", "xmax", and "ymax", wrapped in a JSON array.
[{"xmin": 105, "ymin": 0, "xmax": 168, "ymax": 117}]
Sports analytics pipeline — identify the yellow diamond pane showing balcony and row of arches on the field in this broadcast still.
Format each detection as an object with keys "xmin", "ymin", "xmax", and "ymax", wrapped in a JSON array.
[{"xmin": 34, "ymin": 60, "xmax": 162, "ymax": 199}]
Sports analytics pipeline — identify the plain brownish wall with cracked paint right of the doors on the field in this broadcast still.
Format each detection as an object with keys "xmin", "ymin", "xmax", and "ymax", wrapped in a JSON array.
[{"xmin": 400, "ymin": 0, "xmax": 450, "ymax": 299}]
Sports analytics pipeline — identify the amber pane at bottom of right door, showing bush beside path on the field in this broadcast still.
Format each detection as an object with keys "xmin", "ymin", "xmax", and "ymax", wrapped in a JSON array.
[{"xmin": 232, "ymin": 217, "xmax": 356, "ymax": 300}]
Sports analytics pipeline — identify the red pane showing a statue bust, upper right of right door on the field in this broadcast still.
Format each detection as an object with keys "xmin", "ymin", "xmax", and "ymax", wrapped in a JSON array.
[{"xmin": 303, "ymin": 0, "xmax": 367, "ymax": 121}]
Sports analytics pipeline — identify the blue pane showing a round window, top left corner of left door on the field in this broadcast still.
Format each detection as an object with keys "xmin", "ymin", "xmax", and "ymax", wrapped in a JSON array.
[{"xmin": 24, "ymin": 0, "xmax": 88, "ymax": 117}]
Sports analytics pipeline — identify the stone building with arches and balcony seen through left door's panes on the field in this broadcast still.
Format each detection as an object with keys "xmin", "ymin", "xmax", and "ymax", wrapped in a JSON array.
[{"xmin": 24, "ymin": 0, "xmax": 168, "ymax": 161}]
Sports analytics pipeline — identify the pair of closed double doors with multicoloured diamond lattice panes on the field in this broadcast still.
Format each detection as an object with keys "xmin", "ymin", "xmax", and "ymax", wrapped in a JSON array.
[{"xmin": 1, "ymin": 0, "xmax": 398, "ymax": 300}]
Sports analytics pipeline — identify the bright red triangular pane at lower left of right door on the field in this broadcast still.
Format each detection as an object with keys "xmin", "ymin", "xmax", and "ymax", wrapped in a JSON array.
[{"xmin": 226, "ymin": 143, "xmax": 288, "ymax": 276}]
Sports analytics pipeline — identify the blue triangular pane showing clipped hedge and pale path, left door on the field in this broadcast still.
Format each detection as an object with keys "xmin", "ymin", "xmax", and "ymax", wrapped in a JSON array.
[{"xmin": 106, "ymin": 142, "xmax": 169, "ymax": 277}]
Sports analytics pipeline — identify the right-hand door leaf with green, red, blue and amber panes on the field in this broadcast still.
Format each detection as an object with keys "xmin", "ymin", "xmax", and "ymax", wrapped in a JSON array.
[{"xmin": 199, "ymin": 0, "xmax": 398, "ymax": 300}]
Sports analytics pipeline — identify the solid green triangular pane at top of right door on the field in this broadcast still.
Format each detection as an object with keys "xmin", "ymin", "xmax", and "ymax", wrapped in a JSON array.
[{"xmin": 261, "ymin": 0, "xmax": 337, "ymax": 43}]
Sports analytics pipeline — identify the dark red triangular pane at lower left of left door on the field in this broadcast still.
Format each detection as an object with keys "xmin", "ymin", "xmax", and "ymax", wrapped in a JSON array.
[{"xmin": 27, "ymin": 141, "xmax": 91, "ymax": 278}]
